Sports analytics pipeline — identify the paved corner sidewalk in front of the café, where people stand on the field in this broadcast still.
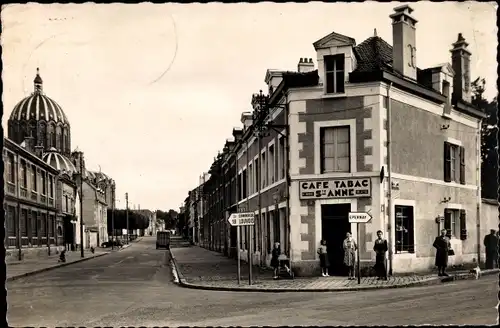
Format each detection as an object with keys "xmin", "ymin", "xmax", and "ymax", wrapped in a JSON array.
[{"xmin": 170, "ymin": 246, "xmax": 499, "ymax": 292}]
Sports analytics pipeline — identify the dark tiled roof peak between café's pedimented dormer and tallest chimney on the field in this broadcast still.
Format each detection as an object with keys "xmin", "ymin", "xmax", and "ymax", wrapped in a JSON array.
[{"xmin": 354, "ymin": 36, "xmax": 392, "ymax": 72}]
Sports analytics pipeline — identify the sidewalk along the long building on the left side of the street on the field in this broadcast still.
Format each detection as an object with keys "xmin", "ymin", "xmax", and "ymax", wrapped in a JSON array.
[{"xmin": 7, "ymin": 248, "xmax": 111, "ymax": 281}]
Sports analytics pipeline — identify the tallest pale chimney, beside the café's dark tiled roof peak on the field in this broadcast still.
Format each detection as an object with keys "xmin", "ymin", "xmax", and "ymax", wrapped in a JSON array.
[{"xmin": 389, "ymin": 5, "xmax": 418, "ymax": 80}]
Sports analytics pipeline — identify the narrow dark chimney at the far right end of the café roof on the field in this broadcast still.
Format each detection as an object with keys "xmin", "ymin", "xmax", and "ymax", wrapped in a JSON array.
[{"xmin": 450, "ymin": 33, "xmax": 471, "ymax": 103}]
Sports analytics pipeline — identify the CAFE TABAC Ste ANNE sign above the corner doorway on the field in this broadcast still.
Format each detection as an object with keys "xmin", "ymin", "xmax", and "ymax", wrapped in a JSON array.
[{"xmin": 299, "ymin": 178, "xmax": 371, "ymax": 199}]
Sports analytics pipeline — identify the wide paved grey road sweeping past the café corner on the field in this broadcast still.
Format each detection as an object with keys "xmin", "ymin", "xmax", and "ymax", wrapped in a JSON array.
[{"xmin": 7, "ymin": 238, "xmax": 498, "ymax": 327}]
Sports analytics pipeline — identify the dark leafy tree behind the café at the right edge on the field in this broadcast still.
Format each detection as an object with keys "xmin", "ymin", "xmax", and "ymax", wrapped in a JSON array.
[{"xmin": 471, "ymin": 77, "xmax": 498, "ymax": 198}]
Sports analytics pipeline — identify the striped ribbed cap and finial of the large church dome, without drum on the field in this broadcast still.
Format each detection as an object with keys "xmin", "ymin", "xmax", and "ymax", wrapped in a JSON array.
[{"xmin": 10, "ymin": 68, "xmax": 69, "ymax": 125}]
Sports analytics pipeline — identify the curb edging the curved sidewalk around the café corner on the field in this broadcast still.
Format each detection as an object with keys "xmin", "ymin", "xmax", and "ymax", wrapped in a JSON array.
[{"xmin": 170, "ymin": 252, "xmax": 500, "ymax": 293}]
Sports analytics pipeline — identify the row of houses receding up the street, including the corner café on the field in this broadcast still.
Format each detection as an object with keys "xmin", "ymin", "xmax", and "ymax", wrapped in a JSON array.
[{"xmin": 185, "ymin": 5, "xmax": 498, "ymax": 275}]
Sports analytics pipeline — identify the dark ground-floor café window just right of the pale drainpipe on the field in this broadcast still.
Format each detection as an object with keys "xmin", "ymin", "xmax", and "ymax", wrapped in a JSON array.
[{"xmin": 394, "ymin": 205, "xmax": 415, "ymax": 253}]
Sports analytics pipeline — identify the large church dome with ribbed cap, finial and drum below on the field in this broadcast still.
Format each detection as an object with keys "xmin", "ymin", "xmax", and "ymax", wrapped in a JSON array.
[{"xmin": 8, "ymin": 69, "xmax": 71, "ymax": 155}]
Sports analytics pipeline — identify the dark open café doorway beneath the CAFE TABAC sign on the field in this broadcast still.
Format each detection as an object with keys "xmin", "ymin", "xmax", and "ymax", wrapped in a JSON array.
[{"xmin": 321, "ymin": 203, "xmax": 351, "ymax": 276}]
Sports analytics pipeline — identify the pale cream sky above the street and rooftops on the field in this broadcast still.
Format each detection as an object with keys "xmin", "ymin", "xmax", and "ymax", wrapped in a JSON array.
[{"xmin": 1, "ymin": 2, "xmax": 497, "ymax": 210}]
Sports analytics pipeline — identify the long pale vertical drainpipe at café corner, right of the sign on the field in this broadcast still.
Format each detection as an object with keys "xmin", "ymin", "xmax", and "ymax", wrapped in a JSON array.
[{"xmin": 386, "ymin": 82, "xmax": 395, "ymax": 276}]
